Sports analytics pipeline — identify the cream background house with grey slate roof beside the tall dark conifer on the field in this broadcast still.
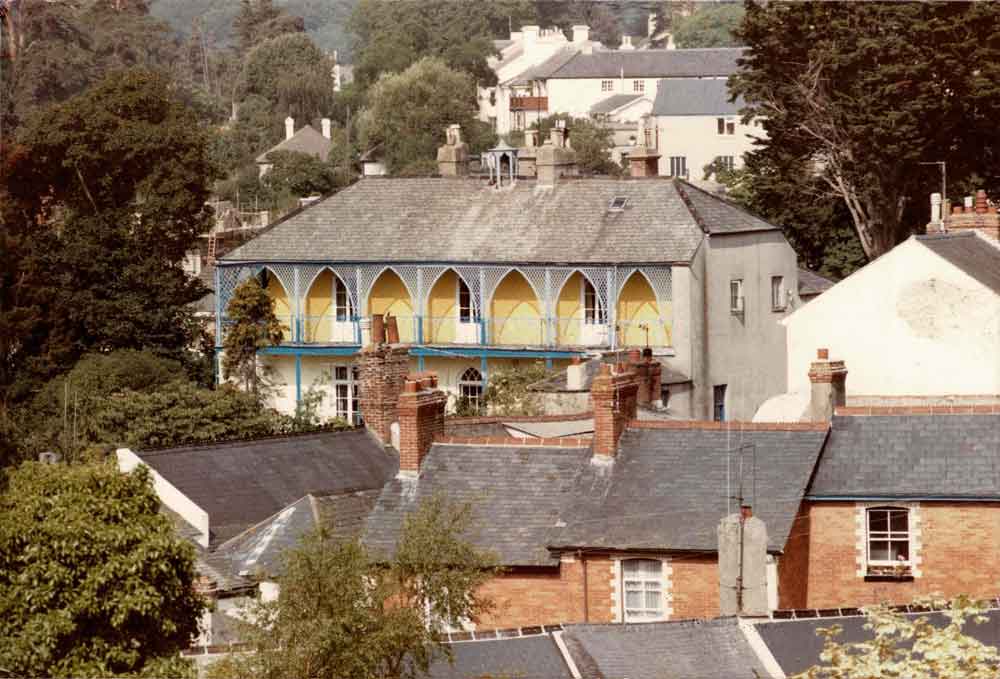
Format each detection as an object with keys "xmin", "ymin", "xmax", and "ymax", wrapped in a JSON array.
[{"xmin": 639, "ymin": 77, "xmax": 766, "ymax": 181}]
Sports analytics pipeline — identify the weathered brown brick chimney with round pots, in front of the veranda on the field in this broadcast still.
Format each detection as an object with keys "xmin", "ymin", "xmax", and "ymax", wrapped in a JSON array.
[{"xmin": 358, "ymin": 346, "xmax": 410, "ymax": 445}]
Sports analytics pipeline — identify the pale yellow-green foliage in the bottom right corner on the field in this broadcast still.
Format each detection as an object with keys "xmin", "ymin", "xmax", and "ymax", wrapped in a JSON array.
[{"xmin": 798, "ymin": 596, "xmax": 1000, "ymax": 679}]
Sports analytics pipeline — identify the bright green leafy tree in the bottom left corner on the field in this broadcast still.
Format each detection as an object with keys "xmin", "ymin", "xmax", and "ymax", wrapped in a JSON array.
[{"xmin": 0, "ymin": 462, "xmax": 204, "ymax": 677}]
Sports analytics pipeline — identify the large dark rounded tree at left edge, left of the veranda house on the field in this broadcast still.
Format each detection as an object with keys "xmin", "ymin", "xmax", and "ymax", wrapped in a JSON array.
[{"xmin": 0, "ymin": 71, "xmax": 214, "ymax": 396}]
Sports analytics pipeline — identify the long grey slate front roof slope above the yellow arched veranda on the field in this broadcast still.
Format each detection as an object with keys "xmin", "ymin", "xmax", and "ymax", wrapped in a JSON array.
[{"xmin": 222, "ymin": 178, "xmax": 712, "ymax": 264}]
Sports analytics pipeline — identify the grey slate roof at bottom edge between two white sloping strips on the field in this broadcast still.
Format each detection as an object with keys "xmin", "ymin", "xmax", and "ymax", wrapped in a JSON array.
[{"xmin": 563, "ymin": 618, "xmax": 770, "ymax": 679}]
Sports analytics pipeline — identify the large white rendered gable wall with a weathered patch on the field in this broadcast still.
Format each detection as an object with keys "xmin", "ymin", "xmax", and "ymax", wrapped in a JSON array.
[{"xmin": 785, "ymin": 238, "xmax": 1000, "ymax": 396}]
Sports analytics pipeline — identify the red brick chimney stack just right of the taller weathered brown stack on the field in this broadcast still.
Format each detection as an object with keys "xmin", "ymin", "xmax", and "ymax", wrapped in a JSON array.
[{"xmin": 399, "ymin": 373, "xmax": 448, "ymax": 477}]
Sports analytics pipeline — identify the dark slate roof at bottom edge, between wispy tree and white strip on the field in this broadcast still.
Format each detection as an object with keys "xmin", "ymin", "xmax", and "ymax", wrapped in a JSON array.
[{"xmin": 428, "ymin": 634, "xmax": 573, "ymax": 679}]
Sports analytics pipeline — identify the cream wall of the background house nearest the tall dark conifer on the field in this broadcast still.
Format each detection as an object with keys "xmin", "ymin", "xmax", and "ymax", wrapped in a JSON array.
[{"xmin": 655, "ymin": 115, "xmax": 766, "ymax": 181}]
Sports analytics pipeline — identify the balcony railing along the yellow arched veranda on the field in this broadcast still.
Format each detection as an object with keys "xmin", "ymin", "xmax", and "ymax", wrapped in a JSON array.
[{"xmin": 254, "ymin": 314, "xmax": 670, "ymax": 347}]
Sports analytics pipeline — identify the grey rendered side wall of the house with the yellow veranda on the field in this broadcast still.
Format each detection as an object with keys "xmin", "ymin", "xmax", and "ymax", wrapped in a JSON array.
[{"xmin": 708, "ymin": 231, "xmax": 800, "ymax": 420}]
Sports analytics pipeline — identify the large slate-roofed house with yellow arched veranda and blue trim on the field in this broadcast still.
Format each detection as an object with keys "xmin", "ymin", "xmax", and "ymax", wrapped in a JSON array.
[{"xmin": 215, "ymin": 123, "xmax": 800, "ymax": 421}]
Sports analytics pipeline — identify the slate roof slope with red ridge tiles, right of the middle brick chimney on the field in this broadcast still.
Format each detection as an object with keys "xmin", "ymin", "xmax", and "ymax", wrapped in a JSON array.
[{"xmin": 551, "ymin": 428, "xmax": 826, "ymax": 552}]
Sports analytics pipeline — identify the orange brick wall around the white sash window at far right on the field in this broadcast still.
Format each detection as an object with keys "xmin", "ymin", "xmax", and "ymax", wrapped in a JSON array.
[{"xmin": 780, "ymin": 502, "xmax": 1000, "ymax": 608}]
